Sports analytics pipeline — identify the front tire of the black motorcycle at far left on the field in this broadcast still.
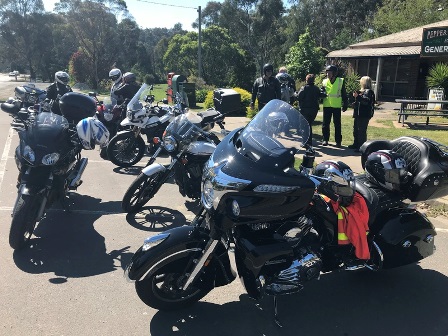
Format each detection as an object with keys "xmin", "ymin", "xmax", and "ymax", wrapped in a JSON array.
[{"xmin": 9, "ymin": 195, "xmax": 40, "ymax": 250}]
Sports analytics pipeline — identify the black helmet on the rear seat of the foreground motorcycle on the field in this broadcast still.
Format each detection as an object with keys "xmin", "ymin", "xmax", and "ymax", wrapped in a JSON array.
[{"xmin": 365, "ymin": 150, "xmax": 411, "ymax": 191}]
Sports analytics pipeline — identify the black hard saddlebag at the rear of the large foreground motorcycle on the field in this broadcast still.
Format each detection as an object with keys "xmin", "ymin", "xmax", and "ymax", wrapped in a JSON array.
[{"xmin": 374, "ymin": 209, "xmax": 437, "ymax": 268}]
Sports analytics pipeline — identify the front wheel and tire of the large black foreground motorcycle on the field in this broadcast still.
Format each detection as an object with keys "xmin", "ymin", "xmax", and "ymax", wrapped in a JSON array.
[{"xmin": 135, "ymin": 243, "xmax": 212, "ymax": 311}]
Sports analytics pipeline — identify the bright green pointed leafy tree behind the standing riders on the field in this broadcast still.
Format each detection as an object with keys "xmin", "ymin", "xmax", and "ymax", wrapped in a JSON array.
[{"xmin": 286, "ymin": 29, "xmax": 325, "ymax": 80}]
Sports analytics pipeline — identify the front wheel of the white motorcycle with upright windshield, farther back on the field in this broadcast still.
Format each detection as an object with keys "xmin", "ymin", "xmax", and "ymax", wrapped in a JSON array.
[{"xmin": 107, "ymin": 133, "xmax": 146, "ymax": 167}]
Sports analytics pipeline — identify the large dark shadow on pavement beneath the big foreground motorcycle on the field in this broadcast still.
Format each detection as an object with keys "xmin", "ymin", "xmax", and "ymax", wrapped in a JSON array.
[{"xmin": 149, "ymin": 265, "xmax": 448, "ymax": 336}]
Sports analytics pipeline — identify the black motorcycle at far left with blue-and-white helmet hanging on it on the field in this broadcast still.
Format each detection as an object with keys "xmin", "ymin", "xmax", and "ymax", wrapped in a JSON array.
[{"xmin": 2, "ymin": 93, "xmax": 109, "ymax": 249}]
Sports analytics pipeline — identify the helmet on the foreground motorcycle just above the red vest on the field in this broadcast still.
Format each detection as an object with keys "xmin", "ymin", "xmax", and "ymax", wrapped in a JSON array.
[{"xmin": 314, "ymin": 160, "xmax": 356, "ymax": 206}]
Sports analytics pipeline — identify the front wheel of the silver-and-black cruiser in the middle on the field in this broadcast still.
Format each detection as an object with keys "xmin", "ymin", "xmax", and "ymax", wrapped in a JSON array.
[{"xmin": 121, "ymin": 172, "xmax": 166, "ymax": 213}]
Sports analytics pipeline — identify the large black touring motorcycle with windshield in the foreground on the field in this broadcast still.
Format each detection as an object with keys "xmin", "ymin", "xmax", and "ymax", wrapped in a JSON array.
[{"xmin": 125, "ymin": 100, "xmax": 442, "ymax": 325}]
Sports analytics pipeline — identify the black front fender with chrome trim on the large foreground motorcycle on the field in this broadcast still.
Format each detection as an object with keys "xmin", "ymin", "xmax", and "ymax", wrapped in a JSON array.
[{"xmin": 125, "ymin": 226, "xmax": 235, "ymax": 286}]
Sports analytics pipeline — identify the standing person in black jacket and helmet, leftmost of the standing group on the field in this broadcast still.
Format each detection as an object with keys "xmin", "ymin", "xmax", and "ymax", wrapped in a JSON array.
[{"xmin": 250, "ymin": 64, "xmax": 282, "ymax": 110}]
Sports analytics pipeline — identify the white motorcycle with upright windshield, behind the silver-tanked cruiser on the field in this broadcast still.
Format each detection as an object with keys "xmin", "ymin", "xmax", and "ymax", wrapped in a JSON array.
[{"xmin": 107, "ymin": 84, "xmax": 178, "ymax": 167}]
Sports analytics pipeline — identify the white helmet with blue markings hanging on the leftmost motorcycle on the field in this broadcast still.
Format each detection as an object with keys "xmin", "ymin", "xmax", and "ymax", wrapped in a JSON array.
[{"xmin": 76, "ymin": 117, "xmax": 109, "ymax": 149}]
